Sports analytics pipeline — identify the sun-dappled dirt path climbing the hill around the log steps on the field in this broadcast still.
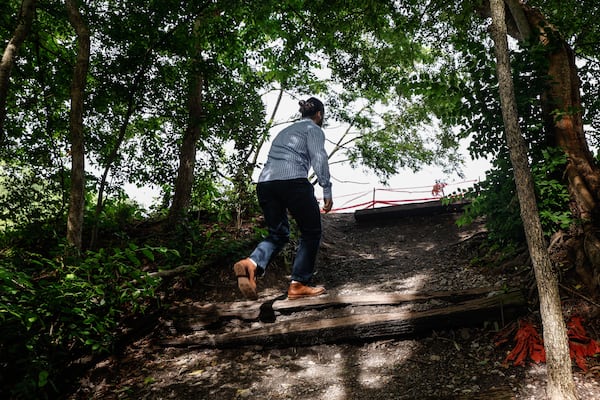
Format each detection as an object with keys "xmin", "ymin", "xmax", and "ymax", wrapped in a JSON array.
[{"xmin": 70, "ymin": 214, "xmax": 600, "ymax": 400}]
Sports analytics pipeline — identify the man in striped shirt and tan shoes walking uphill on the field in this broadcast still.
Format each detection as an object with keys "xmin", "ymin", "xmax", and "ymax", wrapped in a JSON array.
[{"xmin": 233, "ymin": 97, "xmax": 333, "ymax": 300}]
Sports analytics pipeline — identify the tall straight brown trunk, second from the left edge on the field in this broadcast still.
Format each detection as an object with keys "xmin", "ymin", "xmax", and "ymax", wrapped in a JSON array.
[{"xmin": 65, "ymin": 0, "xmax": 90, "ymax": 250}]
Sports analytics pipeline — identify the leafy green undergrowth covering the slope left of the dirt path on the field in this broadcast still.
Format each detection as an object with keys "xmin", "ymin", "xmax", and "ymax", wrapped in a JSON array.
[{"xmin": 0, "ymin": 214, "xmax": 259, "ymax": 399}]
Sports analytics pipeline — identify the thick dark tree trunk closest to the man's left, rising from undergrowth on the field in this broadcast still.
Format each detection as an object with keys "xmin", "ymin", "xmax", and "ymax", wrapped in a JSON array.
[{"xmin": 168, "ymin": 21, "xmax": 204, "ymax": 226}]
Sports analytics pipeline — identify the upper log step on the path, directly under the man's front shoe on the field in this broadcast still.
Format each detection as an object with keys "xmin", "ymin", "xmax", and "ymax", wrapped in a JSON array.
[{"xmin": 171, "ymin": 288, "xmax": 510, "ymax": 331}]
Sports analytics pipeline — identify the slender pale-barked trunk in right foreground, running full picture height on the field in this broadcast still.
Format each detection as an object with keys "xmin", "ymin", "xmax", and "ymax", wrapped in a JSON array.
[{"xmin": 490, "ymin": 0, "xmax": 577, "ymax": 400}]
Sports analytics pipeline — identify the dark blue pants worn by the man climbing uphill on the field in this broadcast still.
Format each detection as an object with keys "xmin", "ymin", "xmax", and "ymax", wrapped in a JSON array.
[{"xmin": 250, "ymin": 179, "xmax": 321, "ymax": 284}]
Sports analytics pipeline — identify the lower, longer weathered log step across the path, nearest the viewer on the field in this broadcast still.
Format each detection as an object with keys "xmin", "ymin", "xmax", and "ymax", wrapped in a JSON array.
[{"xmin": 163, "ymin": 290, "xmax": 526, "ymax": 348}]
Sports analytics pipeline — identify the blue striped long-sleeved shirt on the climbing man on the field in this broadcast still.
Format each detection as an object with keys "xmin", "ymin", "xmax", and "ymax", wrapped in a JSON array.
[{"xmin": 258, "ymin": 118, "xmax": 332, "ymax": 199}]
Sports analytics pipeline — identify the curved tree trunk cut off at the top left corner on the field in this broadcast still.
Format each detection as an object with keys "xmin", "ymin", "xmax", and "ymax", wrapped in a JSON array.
[{"xmin": 0, "ymin": 0, "xmax": 36, "ymax": 144}]
